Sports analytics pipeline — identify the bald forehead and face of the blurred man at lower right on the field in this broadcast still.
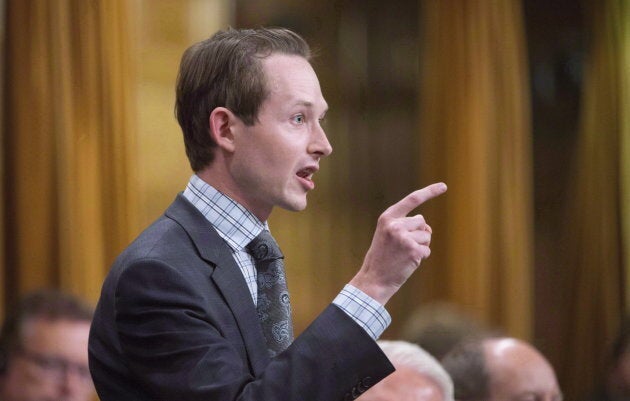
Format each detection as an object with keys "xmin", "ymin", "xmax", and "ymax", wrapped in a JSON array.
[{"xmin": 484, "ymin": 339, "xmax": 562, "ymax": 401}]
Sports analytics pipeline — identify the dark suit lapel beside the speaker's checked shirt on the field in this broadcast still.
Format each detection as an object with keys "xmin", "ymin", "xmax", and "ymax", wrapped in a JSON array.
[{"xmin": 165, "ymin": 194, "xmax": 269, "ymax": 375}]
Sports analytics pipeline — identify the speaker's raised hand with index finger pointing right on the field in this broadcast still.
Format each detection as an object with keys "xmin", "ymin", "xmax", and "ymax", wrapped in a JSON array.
[{"xmin": 350, "ymin": 183, "xmax": 446, "ymax": 305}]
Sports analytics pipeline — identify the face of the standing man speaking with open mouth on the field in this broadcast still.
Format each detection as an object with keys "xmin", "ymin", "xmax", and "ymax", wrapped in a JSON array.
[{"xmin": 229, "ymin": 54, "xmax": 332, "ymax": 220}]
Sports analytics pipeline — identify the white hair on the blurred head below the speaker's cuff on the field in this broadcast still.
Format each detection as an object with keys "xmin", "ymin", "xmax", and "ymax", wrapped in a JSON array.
[{"xmin": 378, "ymin": 340, "xmax": 454, "ymax": 401}]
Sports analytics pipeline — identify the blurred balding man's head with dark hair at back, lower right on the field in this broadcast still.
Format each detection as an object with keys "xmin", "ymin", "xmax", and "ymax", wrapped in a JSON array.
[{"xmin": 442, "ymin": 337, "xmax": 562, "ymax": 401}]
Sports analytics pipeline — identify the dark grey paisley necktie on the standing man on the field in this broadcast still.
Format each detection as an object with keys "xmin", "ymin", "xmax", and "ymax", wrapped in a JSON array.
[{"xmin": 247, "ymin": 230, "xmax": 293, "ymax": 357}]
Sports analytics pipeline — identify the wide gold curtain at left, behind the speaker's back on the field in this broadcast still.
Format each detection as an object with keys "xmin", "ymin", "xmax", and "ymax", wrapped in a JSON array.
[{"xmin": 2, "ymin": 0, "xmax": 135, "ymax": 301}]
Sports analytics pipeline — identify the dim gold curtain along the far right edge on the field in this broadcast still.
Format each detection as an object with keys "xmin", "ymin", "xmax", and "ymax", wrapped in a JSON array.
[{"xmin": 561, "ymin": 0, "xmax": 630, "ymax": 399}]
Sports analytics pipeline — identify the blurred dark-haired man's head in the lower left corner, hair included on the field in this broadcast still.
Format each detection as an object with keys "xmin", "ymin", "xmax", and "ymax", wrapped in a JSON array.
[{"xmin": 0, "ymin": 291, "xmax": 94, "ymax": 401}]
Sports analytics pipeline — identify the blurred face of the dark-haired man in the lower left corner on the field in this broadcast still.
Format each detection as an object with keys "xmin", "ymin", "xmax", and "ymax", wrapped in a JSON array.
[{"xmin": 0, "ymin": 319, "xmax": 94, "ymax": 401}]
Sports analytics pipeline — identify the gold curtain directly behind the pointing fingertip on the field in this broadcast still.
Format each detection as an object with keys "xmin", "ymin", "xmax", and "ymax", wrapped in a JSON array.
[{"xmin": 420, "ymin": 0, "xmax": 533, "ymax": 339}]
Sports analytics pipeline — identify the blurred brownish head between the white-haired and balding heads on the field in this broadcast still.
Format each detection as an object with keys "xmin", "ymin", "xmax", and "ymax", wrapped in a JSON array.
[{"xmin": 400, "ymin": 302, "xmax": 489, "ymax": 361}]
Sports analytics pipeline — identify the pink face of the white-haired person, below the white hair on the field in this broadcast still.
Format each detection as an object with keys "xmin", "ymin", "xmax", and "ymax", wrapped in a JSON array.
[{"xmin": 358, "ymin": 366, "xmax": 444, "ymax": 401}]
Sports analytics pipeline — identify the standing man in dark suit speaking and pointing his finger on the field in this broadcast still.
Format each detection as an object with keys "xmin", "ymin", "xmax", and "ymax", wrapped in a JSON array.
[{"xmin": 89, "ymin": 29, "xmax": 446, "ymax": 401}]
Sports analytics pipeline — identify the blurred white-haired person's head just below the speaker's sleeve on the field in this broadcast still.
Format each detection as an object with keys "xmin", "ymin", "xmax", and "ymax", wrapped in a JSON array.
[{"xmin": 358, "ymin": 340, "xmax": 453, "ymax": 401}]
